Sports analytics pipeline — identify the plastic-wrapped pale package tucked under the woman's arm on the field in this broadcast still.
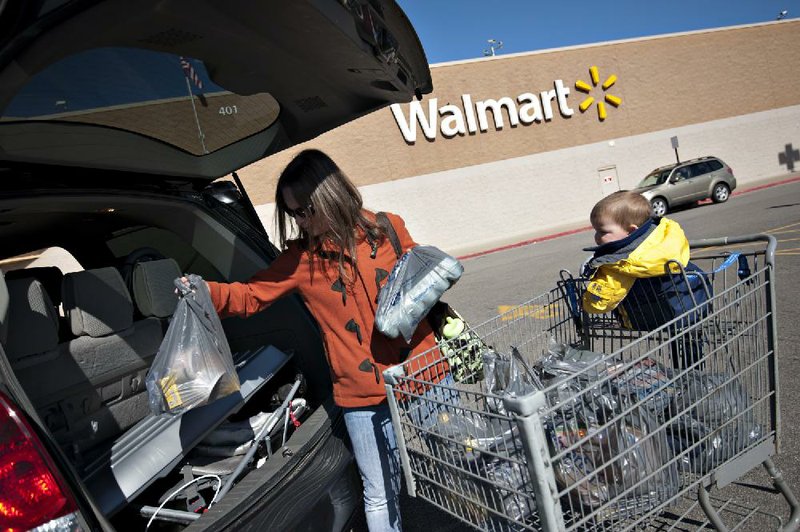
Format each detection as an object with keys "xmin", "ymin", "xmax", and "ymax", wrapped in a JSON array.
[{"xmin": 375, "ymin": 246, "xmax": 464, "ymax": 342}]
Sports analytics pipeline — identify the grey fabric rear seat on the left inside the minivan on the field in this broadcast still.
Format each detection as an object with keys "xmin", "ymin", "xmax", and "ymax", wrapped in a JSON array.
[{"xmin": 8, "ymin": 268, "xmax": 163, "ymax": 463}]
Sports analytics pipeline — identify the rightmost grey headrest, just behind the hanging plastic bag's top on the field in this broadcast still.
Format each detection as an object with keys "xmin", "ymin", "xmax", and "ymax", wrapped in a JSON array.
[{"xmin": 132, "ymin": 259, "xmax": 181, "ymax": 318}]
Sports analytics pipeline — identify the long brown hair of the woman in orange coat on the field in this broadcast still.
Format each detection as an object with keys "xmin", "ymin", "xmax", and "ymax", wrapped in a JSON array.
[{"xmin": 275, "ymin": 150, "xmax": 386, "ymax": 283}]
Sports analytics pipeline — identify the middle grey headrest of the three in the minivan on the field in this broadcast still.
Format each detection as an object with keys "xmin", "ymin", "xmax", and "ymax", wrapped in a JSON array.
[{"xmin": 61, "ymin": 267, "xmax": 133, "ymax": 338}]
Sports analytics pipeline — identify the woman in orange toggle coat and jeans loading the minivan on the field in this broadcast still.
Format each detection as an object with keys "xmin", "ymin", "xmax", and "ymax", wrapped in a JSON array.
[{"xmin": 200, "ymin": 150, "xmax": 435, "ymax": 532}]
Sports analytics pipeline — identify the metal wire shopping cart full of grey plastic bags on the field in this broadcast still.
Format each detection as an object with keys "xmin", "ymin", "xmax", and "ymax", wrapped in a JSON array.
[{"xmin": 384, "ymin": 235, "xmax": 800, "ymax": 531}]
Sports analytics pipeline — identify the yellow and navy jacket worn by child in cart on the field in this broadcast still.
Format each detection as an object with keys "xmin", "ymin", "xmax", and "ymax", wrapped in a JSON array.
[{"xmin": 583, "ymin": 218, "xmax": 689, "ymax": 314}]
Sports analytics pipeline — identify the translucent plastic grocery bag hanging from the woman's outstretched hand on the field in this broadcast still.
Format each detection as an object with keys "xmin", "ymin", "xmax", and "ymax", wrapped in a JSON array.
[{"xmin": 145, "ymin": 275, "xmax": 240, "ymax": 415}]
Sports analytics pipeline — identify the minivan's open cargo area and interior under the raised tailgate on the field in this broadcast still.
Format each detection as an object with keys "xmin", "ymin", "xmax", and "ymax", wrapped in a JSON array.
[{"xmin": 0, "ymin": 183, "xmax": 331, "ymax": 529}]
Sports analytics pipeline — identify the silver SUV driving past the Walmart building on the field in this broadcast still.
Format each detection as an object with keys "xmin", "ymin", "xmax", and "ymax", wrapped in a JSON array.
[{"xmin": 634, "ymin": 157, "xmax": 736, "ymax": 216}]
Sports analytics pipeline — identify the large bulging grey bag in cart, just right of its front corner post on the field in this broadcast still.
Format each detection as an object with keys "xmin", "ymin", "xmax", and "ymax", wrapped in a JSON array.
[{"xmin": 538, "ymin": 340, "xmax": 680, "ymax": 520}]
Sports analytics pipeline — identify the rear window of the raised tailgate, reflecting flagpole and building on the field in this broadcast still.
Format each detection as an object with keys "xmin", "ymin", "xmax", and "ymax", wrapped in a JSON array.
[{"xmin": 0, "ymin": 47, "xmax": 279, "ymax": 155}]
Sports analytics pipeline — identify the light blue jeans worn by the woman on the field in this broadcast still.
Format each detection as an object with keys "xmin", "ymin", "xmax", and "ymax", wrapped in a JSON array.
[{"xmin": 344, "ymin": 404, "xmax": 402, "ymax": 532}]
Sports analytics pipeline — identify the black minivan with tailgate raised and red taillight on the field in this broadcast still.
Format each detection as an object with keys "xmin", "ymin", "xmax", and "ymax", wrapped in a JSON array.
[{"xmin": 0, "ymin": 0, "xmax": 432, "ymax": 531}]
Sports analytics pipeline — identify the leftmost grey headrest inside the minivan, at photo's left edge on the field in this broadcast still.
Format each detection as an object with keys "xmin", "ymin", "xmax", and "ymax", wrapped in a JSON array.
[{"xmin": 5, "ymin": 279, "xmax": 58, "ymax": 363}]
